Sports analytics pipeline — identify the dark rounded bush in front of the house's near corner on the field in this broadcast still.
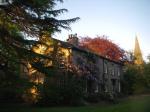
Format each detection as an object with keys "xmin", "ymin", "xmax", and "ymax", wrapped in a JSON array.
[{"xmin": 39, "ymin": 73, "xmax": 84, "ymax": 106}]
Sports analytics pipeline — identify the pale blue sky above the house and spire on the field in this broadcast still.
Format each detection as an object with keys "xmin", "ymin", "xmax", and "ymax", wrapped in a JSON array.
[{"xmin": 54, "ymin": 0, "xmax": 150, "ymax": 59}]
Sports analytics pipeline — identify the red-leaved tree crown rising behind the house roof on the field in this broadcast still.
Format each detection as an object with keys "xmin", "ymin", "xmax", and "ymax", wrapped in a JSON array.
[{"xmin": 80, "ymin": 36, "xmax": 124, "ymax": 61}]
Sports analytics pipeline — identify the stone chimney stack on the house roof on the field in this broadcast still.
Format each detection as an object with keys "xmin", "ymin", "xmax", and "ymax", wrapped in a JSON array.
[{"xmin": 67, "ymin": 34, "xmax": 79, "ymax": 46}]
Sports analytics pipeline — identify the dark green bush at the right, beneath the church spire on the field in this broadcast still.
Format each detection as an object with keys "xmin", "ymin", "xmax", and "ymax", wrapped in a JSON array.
[{"xmin": 122, "ymin": 65, "xmax": 147, "ymax": 95}]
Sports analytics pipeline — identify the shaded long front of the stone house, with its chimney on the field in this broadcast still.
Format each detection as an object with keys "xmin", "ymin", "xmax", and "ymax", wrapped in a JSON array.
[{"xmin": 65, "ymin": 35, "xmax": 123, "ymax": 94}]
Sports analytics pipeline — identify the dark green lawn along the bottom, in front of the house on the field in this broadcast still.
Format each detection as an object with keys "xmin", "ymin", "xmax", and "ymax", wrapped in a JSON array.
[{"xmin": 0, "ymin": 95, "xmax": 150, "ymax": 112}]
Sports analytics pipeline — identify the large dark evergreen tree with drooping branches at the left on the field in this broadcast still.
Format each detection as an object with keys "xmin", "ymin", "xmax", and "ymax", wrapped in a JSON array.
[{"xmin": 0, "ymin": 0, "xmax": 79, "ymax": 102}]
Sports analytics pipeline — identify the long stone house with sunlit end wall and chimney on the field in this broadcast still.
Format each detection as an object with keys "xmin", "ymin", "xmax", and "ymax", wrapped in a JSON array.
[{"xmin": 21, "ymin": 35, "xmax": 123, "ymax": 97}]
